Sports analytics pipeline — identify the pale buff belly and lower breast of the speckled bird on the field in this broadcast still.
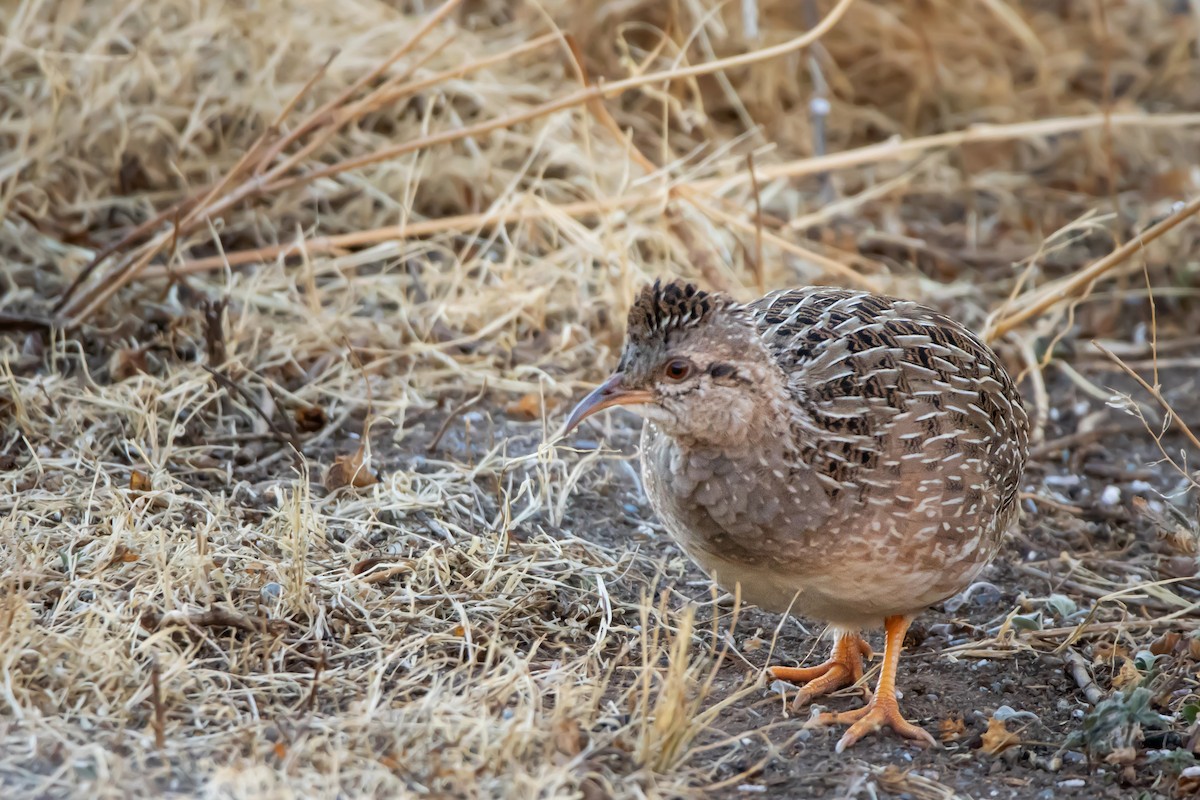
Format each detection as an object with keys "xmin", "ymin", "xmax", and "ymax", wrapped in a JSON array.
[{"xmin": 642, "ymin": 424, "xmax": 1002, "ymax": 627}]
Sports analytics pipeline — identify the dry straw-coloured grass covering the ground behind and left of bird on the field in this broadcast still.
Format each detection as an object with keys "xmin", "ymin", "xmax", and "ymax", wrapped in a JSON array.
[{"xmin": 7, "ymin": 0, "xmax": 1200, "ymax": 799}]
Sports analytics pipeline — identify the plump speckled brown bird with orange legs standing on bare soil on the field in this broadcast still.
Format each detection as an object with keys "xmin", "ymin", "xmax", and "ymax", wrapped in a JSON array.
[{"xmin": 562, "ymin": 279, "xmax": 1030, "ymax": 753}]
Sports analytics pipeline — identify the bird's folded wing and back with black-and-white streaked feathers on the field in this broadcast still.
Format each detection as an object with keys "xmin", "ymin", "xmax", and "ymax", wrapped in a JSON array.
[{"xmin": 749, "ymin": 287, "xmax": 1028, "ymax": 525}]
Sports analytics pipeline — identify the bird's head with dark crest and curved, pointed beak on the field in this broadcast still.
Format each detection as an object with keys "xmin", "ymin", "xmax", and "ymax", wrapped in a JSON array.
[{"xmin": 564, "ymin": 281, "xmax": 784, "ymax": 446}]
